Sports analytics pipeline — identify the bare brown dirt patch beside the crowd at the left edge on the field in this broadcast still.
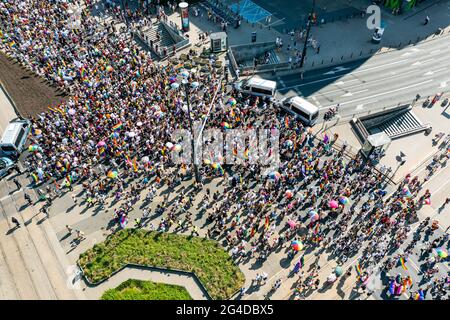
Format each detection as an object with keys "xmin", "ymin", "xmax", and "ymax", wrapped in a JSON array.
[{"xmin": 0, "ymin": 52, "xmax": 67, "ymax": 118}]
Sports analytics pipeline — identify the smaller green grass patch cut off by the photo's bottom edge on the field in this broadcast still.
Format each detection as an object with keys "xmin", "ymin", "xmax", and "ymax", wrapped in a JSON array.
[{"xmin": 102, "ymin": 279, "xmax": 192, "ymax": 300}]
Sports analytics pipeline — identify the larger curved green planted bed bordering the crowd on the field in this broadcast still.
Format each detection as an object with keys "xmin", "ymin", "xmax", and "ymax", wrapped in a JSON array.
[{"xmin": 78, "ymin": 229, "xmax": 245, "ymax": 299}]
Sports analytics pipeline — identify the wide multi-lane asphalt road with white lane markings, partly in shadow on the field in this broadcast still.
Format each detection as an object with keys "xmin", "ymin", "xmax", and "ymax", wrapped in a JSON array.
[{"xmin": 272, "ymin": 36, "xmax": 450, "ymax": 121}]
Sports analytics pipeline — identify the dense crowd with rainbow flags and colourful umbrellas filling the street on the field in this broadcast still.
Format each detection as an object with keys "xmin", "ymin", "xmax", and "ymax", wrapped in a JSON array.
[{"xmin": 0, "ymin": 0, "xmax": 448, "ymax": 297}]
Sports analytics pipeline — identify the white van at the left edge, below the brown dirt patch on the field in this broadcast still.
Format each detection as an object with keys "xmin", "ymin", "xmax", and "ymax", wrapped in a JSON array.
[{"xmin": 0, "ymin": 118, "xmax": 31, "ymax": 158}]
